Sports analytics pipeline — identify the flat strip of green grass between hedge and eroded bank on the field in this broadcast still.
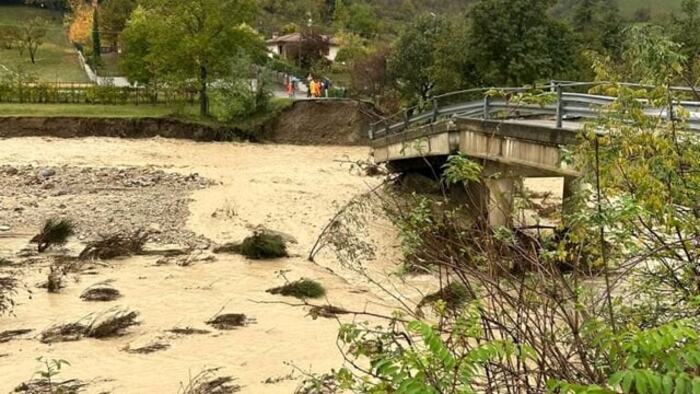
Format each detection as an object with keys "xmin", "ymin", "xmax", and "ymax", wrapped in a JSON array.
[{"xmin": 0, "ymin": 104, "xmax": 191, "ymax": 118}]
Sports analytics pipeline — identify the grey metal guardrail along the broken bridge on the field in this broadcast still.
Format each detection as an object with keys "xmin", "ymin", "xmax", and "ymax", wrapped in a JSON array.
[{"xmin": 369, "ymin": 81, "xmax": 700, "ymax": 140}]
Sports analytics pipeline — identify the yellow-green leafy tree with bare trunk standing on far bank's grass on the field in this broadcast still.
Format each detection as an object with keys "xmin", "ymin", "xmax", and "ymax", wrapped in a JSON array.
[{"xmin": 124, "ymin": 0, "xmax": 264, "ymax": 116}]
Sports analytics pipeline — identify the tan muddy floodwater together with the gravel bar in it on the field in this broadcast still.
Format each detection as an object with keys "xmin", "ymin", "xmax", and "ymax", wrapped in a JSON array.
[{"xmin": 0, "ymin": 138, "xmax": 404, "ymax": 393}]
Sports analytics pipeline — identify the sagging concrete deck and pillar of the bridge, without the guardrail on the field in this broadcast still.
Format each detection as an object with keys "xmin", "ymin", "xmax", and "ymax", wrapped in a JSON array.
[{"xmin": 372, "ymin": 119, "xmax": 578, "ymax": 226}]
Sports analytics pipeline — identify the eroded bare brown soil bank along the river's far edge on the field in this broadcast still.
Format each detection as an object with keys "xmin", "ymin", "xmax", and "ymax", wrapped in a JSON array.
[{"xmin": 0, "ymin": 100, "xmax": 372, "ymax": 145}]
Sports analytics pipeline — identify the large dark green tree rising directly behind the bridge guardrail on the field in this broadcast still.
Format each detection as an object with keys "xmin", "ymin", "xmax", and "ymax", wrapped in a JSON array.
[{"xmin": 469, "ymin": 0, "xmax": 576, "ymax": 85}]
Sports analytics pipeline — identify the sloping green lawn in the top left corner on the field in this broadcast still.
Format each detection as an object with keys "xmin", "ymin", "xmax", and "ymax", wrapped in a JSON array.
[{"xmin": 0, "ymin": 5, "xmax": 88, "ymax": 82}]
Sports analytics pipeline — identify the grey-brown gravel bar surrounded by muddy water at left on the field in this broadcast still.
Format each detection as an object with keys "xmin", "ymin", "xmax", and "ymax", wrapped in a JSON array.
[{"xmin": 0, "ymin": 165, "xmax": 213, "ymax": 243}]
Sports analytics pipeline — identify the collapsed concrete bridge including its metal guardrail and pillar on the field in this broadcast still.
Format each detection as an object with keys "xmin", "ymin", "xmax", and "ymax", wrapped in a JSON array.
[{"xmin": 369, "ymin": 82, "xmax": 700, "ymax": 226}]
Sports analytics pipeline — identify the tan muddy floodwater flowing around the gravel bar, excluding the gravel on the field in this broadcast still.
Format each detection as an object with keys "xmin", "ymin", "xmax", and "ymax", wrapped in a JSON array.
[{"xmin": 0, "ymin": 138, "xmax": 394, "ymax": 393}]
